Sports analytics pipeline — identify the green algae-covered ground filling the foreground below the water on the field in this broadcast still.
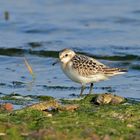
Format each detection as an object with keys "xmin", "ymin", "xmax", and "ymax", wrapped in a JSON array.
[{"xmin": 0, "ymin": 95, "xmax": 140, "ymax": 140}]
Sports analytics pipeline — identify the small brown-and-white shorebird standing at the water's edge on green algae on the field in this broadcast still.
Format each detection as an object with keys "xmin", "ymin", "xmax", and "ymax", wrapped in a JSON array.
[{"xmin": 59, "ymin": 49, "xmax": 127, "ymax": 96}]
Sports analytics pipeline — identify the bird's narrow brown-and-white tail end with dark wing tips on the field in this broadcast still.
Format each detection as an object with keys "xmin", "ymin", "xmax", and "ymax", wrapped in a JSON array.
[{"xmin": 104, "ymin": 68, "xmax": 128, "ymax": 76}]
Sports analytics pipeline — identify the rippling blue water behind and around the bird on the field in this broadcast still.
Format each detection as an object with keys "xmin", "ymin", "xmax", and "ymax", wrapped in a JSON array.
[{"xmin": 0, "ymin": 0, "xmax": 140, "ymax": 106}]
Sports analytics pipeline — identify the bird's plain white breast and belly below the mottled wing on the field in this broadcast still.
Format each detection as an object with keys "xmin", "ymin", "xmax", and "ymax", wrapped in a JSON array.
[{"xmin": 61, "ymin": 64, "xmax": 107, "ymax": 85}]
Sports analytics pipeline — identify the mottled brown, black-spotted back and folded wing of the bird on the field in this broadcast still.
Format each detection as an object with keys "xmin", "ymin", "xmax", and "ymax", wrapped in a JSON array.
[{"xmin": 71, "ymin": 54, "xmax": 124, "ymax": 76}]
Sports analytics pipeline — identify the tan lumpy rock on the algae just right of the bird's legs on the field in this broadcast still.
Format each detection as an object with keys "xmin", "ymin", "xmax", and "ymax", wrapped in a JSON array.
[{"xmin": 95, "ymin": 93, "xmax": 126, "ymax": 105}]
